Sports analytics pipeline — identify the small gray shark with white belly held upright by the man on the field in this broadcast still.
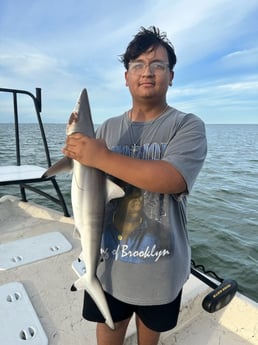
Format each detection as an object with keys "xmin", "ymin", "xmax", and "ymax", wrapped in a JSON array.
[{"xmin": 43, "ymin": 89, "xmax": 124, "ymax": 329}]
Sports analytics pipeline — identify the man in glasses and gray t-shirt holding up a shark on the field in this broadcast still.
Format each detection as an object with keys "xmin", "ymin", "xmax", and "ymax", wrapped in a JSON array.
[{"xmin": 63, "ymin": 27, "xmax": 207, "ymax": 345}]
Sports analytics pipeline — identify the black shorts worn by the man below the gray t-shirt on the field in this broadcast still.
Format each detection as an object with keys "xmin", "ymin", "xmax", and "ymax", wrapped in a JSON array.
[{"xmin": 82, "ymin": 290, "xmax": 182, "ymax": 332}]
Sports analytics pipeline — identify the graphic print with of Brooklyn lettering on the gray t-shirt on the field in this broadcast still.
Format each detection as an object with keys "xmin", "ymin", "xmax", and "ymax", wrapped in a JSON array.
[{"xmin": 101, "ymin": 144, "xmax": 173, "ymax": 263}]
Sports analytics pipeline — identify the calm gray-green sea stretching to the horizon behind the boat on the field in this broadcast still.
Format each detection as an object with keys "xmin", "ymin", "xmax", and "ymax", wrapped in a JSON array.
[{"xmin": 0, "ymin": 124, "xmax": 258, "ymax": 301}]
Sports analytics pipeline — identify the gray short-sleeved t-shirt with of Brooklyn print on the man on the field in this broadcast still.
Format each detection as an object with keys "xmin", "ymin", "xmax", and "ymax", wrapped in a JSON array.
[{"xmin": 97, "ymin": 108, "xmax": 207, "ymax": 305}]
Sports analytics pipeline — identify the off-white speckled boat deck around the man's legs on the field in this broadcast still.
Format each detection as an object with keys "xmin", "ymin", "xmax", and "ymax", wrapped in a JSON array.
[{"xmin": 0, "ymin": 196, "xmax": 258, "ymax": 345}]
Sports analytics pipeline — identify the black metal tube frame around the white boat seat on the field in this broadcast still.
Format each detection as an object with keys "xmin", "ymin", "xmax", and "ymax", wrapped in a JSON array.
[{"xmin": 0, "ymin": 88, "xmax": 70, "ymax": 217}]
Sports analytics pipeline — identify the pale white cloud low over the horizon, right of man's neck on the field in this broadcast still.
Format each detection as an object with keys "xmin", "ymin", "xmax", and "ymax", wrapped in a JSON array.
[{"xmin": 168, "ymin": 75, "xmax": 258, "ymax": 123}]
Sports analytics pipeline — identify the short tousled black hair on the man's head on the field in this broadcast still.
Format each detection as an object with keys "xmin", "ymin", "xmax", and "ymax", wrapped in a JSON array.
[{"xmin": 120, "ymin": 26, "xmax": 177, "ymax": 71}]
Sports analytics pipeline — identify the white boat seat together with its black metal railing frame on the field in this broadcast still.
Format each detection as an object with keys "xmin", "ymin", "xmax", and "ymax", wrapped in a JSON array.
[{"xmin": 0, "ymin": 88, "xmax": 69, "ymax": 217}]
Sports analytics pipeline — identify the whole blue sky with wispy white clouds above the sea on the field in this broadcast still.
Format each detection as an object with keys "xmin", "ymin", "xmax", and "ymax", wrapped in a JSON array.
[{"xmin": 0, "ymin": 0, "xmax": 258, "ymax": 123}]
